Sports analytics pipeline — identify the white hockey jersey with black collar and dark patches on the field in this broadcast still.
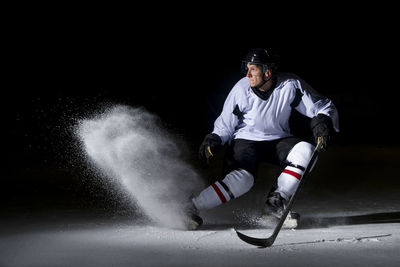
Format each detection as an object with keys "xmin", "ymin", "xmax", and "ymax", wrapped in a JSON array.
[{"xmin": 213, "ymin": 73, "xmax": 339, "ymax": 144}]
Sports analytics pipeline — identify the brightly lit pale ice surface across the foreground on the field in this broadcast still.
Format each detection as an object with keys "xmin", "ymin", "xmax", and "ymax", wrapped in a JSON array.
[{"xmin": 0, "ymin": 221, "xmax": 400, "ymax": 267}]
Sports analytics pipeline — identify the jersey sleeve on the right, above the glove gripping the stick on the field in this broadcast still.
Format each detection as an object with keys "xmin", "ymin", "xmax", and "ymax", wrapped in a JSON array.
[{"xmin": 292, "ymin": 79, "xmax": 339, "ymax": 132}]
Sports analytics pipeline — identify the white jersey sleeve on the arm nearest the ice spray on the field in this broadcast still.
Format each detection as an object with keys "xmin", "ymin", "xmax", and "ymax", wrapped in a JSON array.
[{"xmin": 213, "ymin": 82, "xmax": 241, "ymax": 144}]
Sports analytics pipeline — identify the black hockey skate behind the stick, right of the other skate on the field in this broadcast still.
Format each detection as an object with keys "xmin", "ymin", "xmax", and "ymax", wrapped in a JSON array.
[{"xmin": 263, "ymin": 192, "xmax": 300, "ymax": 229}]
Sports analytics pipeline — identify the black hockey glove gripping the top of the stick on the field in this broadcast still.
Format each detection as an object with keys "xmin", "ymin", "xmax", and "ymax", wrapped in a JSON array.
[{"xmin": 311, "ymin": 114, "xmax": 333, "ymax": 151}]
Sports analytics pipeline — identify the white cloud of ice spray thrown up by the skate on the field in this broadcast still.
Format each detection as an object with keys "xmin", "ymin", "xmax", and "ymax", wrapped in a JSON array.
[{"xmin": 76, "ymin": 105, "xmax": 202, "ymax": 228}]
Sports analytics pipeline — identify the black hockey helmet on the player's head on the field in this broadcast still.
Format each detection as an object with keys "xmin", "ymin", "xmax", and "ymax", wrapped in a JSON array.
[{"xmin": 242, "ymin": 48, "xmax": 279, "ymax": 73}]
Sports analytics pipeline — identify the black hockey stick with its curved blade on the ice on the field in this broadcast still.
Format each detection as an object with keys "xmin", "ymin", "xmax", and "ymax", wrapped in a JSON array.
[{"xmin": 235, "ymin": 137, "xmax": 322, "ymax": 247}]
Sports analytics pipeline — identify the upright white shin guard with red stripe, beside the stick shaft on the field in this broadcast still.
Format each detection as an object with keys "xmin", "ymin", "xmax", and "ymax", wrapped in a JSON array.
[{"xmin": 275, "ymin": 142, "xmax": 314, "ymax": 200}]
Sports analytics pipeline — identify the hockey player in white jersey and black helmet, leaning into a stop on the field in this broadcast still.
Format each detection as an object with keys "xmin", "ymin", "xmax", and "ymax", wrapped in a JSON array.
[{"xmin": 188, "ymin": 48, "xmax": 339, "ymax": 229}]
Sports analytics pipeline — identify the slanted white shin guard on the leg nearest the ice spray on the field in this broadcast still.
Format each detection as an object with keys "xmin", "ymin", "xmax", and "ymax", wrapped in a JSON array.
[{"xmin": 192, "ymin": 169, "xmax": 254, "ymax": 210}]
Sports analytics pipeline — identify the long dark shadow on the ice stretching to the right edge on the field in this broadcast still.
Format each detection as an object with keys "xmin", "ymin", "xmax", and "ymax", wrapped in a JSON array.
[{"xmin": 297, "ymin": 212, "xmax": 400, "ymax": 229}]
